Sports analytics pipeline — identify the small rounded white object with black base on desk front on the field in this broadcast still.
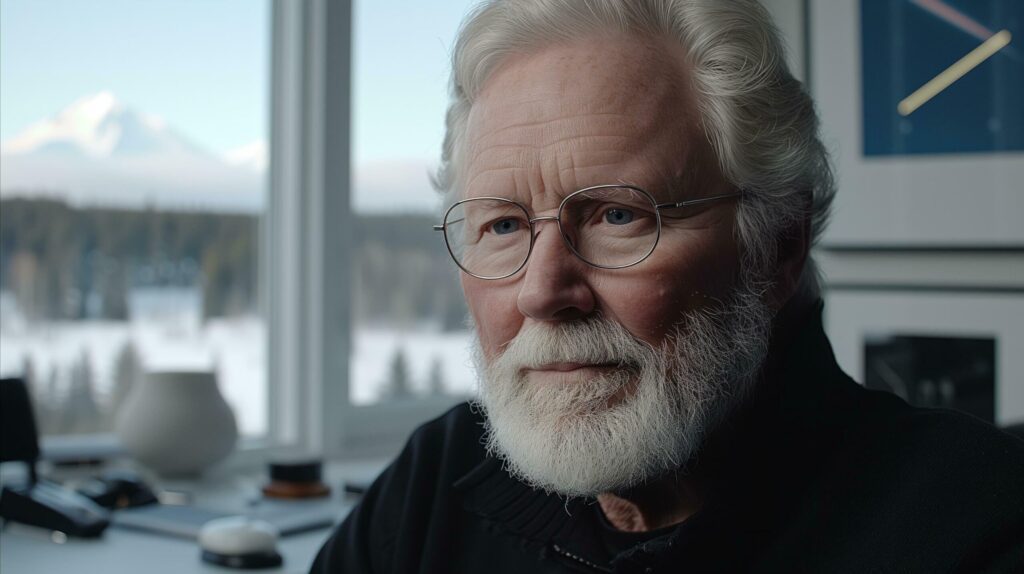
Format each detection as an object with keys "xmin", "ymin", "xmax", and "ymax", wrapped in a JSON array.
[{"xmin": 199, "ymin": 517, "xmax": 284, "ymax": 570}]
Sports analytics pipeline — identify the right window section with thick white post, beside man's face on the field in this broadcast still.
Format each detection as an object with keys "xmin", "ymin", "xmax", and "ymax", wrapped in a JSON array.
[{"xmin": 267, "ymin": 0, "xmax": 483, "ymax": 455}]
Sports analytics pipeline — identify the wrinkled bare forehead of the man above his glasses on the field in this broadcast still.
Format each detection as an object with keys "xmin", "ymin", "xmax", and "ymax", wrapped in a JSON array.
[{"xmin": 460, "ymin": 36, "xmax": 701, "ymax": 203}]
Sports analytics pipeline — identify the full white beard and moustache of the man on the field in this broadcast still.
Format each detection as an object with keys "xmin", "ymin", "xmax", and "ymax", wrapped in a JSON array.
[{"xmin": 474, "ymin": 280, "xmax": 773, "ymax": 496}]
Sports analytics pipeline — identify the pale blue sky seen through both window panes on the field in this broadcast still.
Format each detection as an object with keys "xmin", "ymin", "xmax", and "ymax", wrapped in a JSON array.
[{"xmin": 0, "ymin": 0, "xmax": 472, "ymax": 171}]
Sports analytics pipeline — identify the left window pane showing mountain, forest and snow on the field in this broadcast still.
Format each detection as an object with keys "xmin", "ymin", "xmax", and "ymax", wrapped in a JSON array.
[{"xmin": 0, "ymin": 0, "xmax": 270, "ymax": 444}]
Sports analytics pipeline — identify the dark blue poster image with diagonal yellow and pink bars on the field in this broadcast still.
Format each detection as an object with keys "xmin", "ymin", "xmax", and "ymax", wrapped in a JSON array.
[{"xmin": 860, "ymin": 0, "xmax": 1024, "ymax": 157}]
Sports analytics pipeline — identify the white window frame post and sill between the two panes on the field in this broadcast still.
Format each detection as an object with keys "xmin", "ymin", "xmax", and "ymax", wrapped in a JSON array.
[{"xmin": 263, "ymin": 0, "xmax": 466, "ymax": 457}]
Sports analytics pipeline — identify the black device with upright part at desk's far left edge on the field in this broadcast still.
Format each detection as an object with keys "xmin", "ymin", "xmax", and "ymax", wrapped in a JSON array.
[{"xmin": 0, "ymin": 379, "xmax": 110, "ymax": 537}]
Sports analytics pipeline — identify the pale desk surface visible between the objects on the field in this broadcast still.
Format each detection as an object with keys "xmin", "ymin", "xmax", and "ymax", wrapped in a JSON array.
[{"xmin": 0, "ymin": 460, "xmax": 386, "ymax": 574}]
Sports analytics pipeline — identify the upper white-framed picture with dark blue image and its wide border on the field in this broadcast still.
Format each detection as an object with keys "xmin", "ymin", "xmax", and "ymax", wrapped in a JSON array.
[{"xmin": 809, "ymin": 0, "xmax": 1024, "ymax": 248}]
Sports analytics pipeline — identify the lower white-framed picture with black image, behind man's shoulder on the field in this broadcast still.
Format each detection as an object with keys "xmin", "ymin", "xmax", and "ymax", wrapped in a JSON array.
[{"xmin": 825, "ymin": 290, "xmax": 1024, "ymax": 426}]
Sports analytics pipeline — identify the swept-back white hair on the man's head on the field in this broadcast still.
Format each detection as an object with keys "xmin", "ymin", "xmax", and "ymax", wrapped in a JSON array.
[{"xmin": 434, "ymin": 0, "xmax": 836, "ymax": 294}]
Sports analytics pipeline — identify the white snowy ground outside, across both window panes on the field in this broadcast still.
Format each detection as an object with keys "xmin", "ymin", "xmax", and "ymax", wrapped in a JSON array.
[{"xmin": 0, "ymin": 293, "xmax": 475, "ymax": 436}]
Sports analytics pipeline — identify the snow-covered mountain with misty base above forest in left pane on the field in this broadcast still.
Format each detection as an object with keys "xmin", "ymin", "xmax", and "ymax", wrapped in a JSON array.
[{"xmin": 0, "ymin": 92, "xmax": 266, "ymax": 211}]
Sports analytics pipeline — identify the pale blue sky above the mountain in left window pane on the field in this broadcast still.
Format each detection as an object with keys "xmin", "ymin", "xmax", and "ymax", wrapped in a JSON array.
[{"xmin": 0, "ymin": 0, "xmax": 270, "ymax": 152}]
